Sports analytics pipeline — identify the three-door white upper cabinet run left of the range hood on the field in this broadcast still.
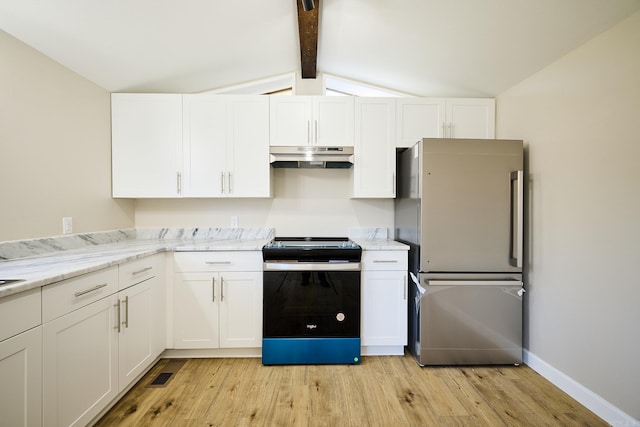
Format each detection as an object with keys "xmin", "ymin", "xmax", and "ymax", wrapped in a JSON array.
[{"xmin": 111, "ymin": 94, "xmax": 271, "ymax": 198}]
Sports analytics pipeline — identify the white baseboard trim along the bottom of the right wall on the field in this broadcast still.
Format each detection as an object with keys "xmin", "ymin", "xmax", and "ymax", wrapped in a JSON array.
[{"xmin": 523, "ymin": 349, "xmax": 640, "ymax": 427}]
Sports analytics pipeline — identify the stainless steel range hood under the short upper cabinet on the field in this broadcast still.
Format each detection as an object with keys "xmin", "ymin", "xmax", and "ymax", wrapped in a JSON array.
[{"xmin": 269, "ymin": 145, "xmax": 353, "ymax": 169}]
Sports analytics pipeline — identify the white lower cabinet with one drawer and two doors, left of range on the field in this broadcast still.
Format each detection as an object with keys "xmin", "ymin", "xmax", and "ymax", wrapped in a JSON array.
[{"xmin": 173, "ymin": 252, "xmax": 262, "ymax": 349}]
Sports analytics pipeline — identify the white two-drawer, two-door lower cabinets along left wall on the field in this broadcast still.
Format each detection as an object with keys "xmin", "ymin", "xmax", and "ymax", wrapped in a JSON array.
[{"xmin": 42, "ymin": 257, "xmax": 165, "ymax": 426}]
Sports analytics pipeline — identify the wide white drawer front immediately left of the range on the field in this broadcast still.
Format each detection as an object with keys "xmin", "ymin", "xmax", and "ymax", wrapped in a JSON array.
[{"xmin": 174, "ymin": 251, "xmax": 262, "ymax": 272}]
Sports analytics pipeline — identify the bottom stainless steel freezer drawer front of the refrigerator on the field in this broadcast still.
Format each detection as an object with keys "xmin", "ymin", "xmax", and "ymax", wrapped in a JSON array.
[{"xmin": 410, "ymin": 280, "xmax": 522, "ymax": 365}]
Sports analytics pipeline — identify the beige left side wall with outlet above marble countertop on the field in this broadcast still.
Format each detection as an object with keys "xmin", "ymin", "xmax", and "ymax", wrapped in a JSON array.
[{"xmin": 0, "ymin": 30, "xmax": 134, "ymax": 241}]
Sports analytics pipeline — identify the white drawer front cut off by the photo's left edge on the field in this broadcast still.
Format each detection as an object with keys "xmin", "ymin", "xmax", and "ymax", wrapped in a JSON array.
[{"xmin": 0, "ymin": 288, "xmax": 42, "ymax": 341}]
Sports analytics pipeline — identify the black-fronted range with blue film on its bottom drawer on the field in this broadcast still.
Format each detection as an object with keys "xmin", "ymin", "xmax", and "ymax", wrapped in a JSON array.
[{"xmin": 262, "ymin": 237, "xmax": 362, "ymax": 365}]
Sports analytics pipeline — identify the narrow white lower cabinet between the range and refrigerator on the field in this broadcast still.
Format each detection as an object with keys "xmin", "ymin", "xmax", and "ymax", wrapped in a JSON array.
[{"xmin": 361, "ymin": 250, "xmax": 408, "ymax": 356}]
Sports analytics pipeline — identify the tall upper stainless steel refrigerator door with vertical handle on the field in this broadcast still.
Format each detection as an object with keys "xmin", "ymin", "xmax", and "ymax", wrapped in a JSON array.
[{"xmin": 419, "ymin": 139, "xmax": 523, "ymax": 272}]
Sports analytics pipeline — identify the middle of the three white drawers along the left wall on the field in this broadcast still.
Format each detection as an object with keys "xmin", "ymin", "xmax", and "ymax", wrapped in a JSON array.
[{"xmin": 42, "ymin": 266, "xmax": 118, "ymax": 322}]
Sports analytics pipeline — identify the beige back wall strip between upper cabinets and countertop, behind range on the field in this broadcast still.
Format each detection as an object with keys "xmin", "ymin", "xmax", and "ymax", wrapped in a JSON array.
[{"xmin": 136, "ymin": 169, "xmax": 393, "ymax": 236}]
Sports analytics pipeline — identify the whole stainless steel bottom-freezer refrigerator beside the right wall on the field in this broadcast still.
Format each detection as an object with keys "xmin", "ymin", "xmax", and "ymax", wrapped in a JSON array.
[{"xmin": 395, "ymin": 139, "xmax": 524, "ymax": 365}]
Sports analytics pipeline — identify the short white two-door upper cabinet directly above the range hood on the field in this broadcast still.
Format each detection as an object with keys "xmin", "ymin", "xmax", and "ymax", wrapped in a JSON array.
[{"xmin": 270, "ymin": 95, "xmax": 354, "ymax": 147}]
